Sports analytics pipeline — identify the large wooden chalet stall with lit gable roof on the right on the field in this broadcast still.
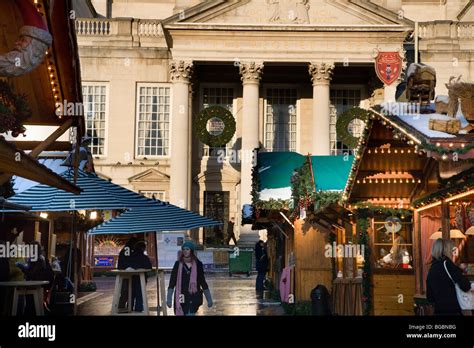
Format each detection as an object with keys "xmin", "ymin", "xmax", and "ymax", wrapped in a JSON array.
[{"xmin": 343, "ymin": 93, "xmax": 474, "ymax": 315}]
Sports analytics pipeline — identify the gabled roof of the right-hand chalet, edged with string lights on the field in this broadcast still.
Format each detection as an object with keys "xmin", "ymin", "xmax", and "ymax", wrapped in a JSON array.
[{"xmin": 343, "ymin": 103, "xmax": 474, "ymax": 208}]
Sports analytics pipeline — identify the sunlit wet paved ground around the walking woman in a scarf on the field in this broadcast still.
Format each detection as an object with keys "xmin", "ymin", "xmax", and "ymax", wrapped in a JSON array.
[{"xmin": 78, "ymin": 273, "xmax": 282, "ymax": 315}]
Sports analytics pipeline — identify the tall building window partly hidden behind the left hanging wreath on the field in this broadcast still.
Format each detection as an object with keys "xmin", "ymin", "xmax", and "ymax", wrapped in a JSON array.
[{"xmin": 202, "ymin": 86, "xmax": 235, "ymax": 157}]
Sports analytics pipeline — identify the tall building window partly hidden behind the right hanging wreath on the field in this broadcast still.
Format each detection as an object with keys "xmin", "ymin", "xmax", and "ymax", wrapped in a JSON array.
[{"xmin": 330, "ymin": 88, "xmax": 364, "ymax": 156}]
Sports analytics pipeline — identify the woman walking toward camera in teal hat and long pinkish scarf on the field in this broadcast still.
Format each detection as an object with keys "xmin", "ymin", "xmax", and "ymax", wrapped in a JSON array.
[{"xmin": 166, "ymin": 241, "xmax": 212, "ymax": 315}]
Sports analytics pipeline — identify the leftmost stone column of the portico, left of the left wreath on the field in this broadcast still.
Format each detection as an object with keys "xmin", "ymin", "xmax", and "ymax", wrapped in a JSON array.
[{"xmin": 170, "ymin": 60, "xmax": 193, "ymax": 209}]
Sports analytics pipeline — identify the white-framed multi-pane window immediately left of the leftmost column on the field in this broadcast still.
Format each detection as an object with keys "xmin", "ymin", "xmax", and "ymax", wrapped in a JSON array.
[{"xmin": 137, "ymin": 85, "xmax": 171, "ymax": 157}]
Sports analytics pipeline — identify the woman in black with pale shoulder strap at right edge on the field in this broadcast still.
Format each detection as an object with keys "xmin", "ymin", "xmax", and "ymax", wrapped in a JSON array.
[{"xmin": 426, "ymin": 239, "xmax": 471, "ymax": 315}]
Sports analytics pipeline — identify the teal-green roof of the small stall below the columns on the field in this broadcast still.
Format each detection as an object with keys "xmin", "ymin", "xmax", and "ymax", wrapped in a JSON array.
[{"xmin": 257, "ymin": 152, "xmax": 353, "ymax": 200}]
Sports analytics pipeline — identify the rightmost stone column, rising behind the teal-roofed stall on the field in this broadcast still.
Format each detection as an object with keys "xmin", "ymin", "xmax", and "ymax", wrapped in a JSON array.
[{"xmin": 309, "ymin": 63, "xmax": 334, "ymax": 155}]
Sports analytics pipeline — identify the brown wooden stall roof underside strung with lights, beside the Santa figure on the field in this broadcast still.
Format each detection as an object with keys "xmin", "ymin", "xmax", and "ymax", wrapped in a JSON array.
[{"xmin": 0, "ymin": 0, "xmax": 84, "ymax": 130}]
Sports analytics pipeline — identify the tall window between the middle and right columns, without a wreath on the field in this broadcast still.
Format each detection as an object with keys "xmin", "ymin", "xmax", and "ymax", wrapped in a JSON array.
[{"xmin": 265, "ymin": 88, "xmax": 297, "ymax": 151}]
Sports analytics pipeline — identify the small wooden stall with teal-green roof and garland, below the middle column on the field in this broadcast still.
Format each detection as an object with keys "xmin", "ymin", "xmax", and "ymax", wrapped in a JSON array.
[{"xmin": 253, "ymin": 152, "xmax": 352, "ymax": 302}]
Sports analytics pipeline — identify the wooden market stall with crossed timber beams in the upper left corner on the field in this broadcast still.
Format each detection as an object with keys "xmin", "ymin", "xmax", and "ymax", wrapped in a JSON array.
[{"xmin": 0, "ymin": 0, "xmax": 84, "ymax": 193}]
